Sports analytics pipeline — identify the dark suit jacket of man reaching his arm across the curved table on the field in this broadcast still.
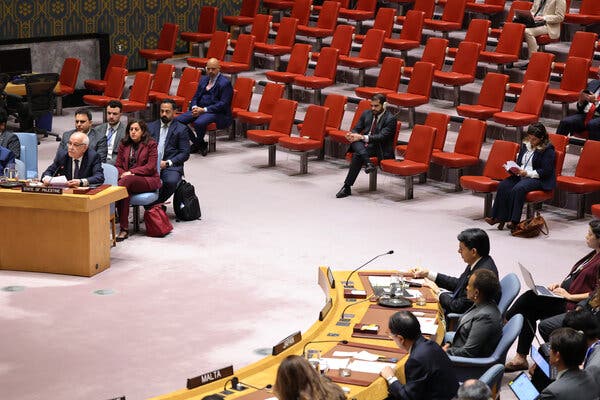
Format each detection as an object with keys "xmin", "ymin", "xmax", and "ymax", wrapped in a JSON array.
[{"xmin": 435, "ymin": 255, "xmax": 500, "ymax": 314}]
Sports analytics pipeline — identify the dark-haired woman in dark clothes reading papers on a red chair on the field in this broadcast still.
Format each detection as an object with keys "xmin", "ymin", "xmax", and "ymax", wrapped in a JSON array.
[{"xmin": 485, "ymin": 122, "xmax": 556, "ymax": 230}]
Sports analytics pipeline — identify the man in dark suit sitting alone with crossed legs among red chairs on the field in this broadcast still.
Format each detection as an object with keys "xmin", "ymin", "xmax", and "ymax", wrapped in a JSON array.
[{"xmin": 335, "ymin": 94, "xmax": 396, "ymax": 199}]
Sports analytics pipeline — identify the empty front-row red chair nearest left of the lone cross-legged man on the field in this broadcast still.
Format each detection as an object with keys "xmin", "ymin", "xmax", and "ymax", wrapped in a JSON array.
[{"xmin": 279, "ymin": 104, "xmax": 329, "ymax": 174}]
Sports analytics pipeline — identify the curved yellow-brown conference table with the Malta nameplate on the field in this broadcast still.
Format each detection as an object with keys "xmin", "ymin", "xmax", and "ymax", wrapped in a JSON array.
[{"xmin": 153, "ymin": 267, "xmax": 445, "ymax": 400}]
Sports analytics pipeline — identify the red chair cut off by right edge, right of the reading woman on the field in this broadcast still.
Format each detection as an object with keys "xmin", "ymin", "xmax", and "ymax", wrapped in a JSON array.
[{"xmin": 556, "ymin": 140, "xmax": 600, "ymax": 219}]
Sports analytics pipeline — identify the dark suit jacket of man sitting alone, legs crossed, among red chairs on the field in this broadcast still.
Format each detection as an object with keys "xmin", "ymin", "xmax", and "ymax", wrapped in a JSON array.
[{"xmin": 352, "ymin": 110, "xmax": 396, "ymax": 160}]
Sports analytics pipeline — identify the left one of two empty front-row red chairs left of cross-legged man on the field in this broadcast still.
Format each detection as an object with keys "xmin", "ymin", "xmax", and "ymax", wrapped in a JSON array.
[{"xmin": 246, "ymin": 99, "xmax": 298, "ymax": 167}]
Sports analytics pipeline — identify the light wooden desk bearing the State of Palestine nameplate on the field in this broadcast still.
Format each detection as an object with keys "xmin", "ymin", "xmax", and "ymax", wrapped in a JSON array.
[{"xmin": 0, "ymin": 186, "xmax": 127, "ymax": 276}]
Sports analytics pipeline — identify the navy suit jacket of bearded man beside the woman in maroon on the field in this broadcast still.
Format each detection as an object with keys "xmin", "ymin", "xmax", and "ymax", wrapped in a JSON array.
[{"xmin": 148, "ymin": 120, "xmax": 190, "ymax": 174}]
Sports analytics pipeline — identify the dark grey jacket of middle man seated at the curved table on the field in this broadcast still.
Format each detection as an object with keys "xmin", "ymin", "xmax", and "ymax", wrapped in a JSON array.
[{"xmin": 447, "ymin": 301, "xmax": 502, "ymax": 358}]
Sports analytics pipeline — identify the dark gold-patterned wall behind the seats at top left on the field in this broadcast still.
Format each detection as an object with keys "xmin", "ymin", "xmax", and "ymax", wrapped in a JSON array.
[{"xmin": 0, "ymin": 0, "xmax": 242, "ymax": 70}]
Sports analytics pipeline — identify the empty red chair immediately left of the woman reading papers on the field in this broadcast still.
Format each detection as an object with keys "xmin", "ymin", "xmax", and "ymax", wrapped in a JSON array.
[{"xmin": 460, "ymin": 140, "xmax": 519, "ymax": 218}]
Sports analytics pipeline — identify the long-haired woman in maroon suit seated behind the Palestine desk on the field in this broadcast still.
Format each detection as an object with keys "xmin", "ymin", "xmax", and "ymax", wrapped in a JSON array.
[{"xmin": 115, "ymin": 120, "xmax": 161, "ymax": 242}]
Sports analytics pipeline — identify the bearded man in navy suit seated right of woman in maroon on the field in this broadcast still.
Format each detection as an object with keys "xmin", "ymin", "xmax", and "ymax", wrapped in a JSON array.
[{"xmin": 148, "ymin": 99, "xmax": 190, "ymax": 203}]
